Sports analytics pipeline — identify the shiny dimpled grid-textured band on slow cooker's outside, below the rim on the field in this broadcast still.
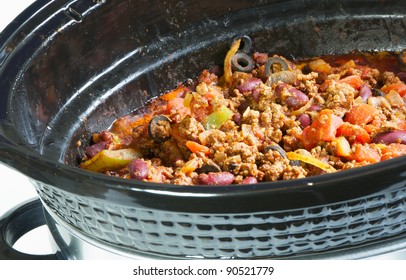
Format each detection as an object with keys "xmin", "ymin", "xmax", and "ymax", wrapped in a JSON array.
[{"xmin": 34, "ymin": 182, "xmax": 406, "ymax": 259}]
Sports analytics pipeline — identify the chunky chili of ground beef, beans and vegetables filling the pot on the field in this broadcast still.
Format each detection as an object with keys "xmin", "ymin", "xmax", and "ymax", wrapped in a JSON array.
[{"xmin": 78, "ymin": 46, "xmax": 406, "ymax": 185}]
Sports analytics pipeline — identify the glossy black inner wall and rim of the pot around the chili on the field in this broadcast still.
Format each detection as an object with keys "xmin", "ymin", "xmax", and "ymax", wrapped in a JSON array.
[{"xmin": 0, "ymin": 0, "xmax": 406, "ymax": 213}]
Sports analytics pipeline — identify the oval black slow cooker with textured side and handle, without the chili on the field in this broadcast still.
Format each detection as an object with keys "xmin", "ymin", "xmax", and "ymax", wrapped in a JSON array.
[{"xmin": 0, "ymin": 0, "xmax": 406, "ymax": 259}]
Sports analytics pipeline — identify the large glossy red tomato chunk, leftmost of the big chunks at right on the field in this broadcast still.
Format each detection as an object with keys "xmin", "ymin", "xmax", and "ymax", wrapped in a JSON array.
[{"xmin": 302, "ymin": 109, "xmax": 343, "ymax": 150}]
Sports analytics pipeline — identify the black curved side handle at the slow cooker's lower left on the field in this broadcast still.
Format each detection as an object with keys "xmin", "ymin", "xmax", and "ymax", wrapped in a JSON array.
[{"xmin": 0, "ymin": 198, "xmax": 58, "ymax": 260}]
